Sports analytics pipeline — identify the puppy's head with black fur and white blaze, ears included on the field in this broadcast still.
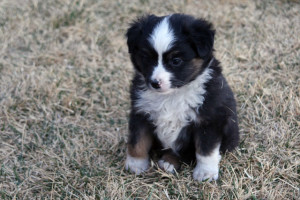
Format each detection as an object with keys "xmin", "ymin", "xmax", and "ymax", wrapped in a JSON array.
[{"xmin": 126, "ymin": 14, "xmax": 215, "ymax": 93}]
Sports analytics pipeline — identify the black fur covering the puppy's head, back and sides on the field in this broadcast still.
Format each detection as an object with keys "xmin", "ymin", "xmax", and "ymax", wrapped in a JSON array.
[{"xmin": 126, "ymin": 14, "xmax": 239, "ymax": 165}]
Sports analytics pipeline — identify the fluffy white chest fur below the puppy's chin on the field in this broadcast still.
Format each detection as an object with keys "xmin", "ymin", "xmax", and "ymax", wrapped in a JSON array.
[{"xmin": 135, "ymin": 68, "xmax": 212, "ymax": 149}]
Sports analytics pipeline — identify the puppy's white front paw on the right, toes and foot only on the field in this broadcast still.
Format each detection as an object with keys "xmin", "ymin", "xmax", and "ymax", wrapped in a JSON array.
[{"xmin": 193, "ymin": 164, "xmax": 219, "ymax": 182}]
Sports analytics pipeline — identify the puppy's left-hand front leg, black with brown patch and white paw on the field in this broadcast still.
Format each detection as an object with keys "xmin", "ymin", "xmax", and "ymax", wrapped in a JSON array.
[{"xmin": 125, "ymin": 113, "xmax": 153, "ymax": 174}]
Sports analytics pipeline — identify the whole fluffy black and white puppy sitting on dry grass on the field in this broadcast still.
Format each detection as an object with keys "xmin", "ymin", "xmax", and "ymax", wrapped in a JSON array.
[{"xmin": 125, "ymin": 14, "xmax": 239, "ymax": 181}]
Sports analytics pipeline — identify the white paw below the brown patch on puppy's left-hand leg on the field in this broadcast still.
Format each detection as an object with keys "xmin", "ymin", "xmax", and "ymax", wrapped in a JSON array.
[{"xmin": 125, "ymin": 155, "xmax": 149, "ymax": 175}]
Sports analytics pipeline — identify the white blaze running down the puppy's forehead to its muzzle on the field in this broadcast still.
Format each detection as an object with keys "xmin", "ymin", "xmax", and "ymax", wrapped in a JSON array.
[{"xmin": 148, "ymin": 17, "xmax": 175, "ymax": 92}]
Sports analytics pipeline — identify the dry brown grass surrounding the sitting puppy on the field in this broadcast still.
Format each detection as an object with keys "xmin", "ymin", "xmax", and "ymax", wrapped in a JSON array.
[{"xmin": 0, "ymin": 0, "xmax": 300, "ymax": 199}]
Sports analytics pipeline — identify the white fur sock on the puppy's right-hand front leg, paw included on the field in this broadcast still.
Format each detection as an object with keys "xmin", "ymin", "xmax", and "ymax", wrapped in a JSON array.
[{"xmin": 193, "ymin": 145, "xmax": 221, "ymax": 181}]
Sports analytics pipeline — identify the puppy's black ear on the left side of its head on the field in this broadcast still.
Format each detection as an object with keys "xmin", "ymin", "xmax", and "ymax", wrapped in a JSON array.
[{"xmin": 126, "ymin": 19, "xmax": 142, "ymax": 54}]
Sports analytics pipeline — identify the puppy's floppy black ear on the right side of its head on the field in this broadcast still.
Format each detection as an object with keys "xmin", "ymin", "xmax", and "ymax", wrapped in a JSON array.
[{"xmin": 188, "ymin": 19, "xmax": 215, "ymax": 58}]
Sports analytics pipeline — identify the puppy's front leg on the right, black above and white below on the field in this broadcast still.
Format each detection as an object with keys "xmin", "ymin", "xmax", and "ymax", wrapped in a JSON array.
[{"xmin": 193, "ymin": 128, "xmax": 221, "ymax": 181}]
